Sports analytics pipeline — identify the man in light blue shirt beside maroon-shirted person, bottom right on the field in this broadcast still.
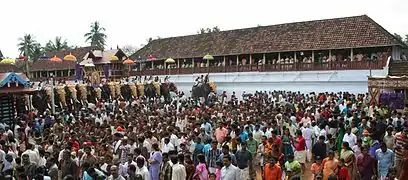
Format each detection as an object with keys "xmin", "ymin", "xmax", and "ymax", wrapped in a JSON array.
[{"xmin": 375, "ymin": 142, "xmax": 395, "ymax": 179}]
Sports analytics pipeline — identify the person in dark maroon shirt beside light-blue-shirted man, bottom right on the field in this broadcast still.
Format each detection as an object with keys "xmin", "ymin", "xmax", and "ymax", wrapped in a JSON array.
[{"xmin": 356, "ymin": 146, "xmax": 377, "ymax": 180}]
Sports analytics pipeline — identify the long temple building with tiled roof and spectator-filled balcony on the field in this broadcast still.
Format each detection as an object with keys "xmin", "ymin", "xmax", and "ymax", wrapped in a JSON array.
[{"xmin": 130, "ymin": 15, "xmax": 407, "ymax": 75}]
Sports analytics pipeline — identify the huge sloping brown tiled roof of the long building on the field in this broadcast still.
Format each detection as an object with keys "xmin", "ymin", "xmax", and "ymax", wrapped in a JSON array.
[{"xmin": 131, "ymin": 15, "xmax": 402, "ymax": 59}]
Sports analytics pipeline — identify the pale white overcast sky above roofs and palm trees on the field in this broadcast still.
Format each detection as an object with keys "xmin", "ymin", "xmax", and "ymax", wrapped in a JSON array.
[{"xmin": 0, "ymin": 0, "xmax": 408, "ymax": 57}]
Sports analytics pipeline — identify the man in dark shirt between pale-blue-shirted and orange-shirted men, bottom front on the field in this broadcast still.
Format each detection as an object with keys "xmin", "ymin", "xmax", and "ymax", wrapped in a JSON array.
[{"xmin": 235, "ymin": 142, "xmax": 253, "ymax": 179}]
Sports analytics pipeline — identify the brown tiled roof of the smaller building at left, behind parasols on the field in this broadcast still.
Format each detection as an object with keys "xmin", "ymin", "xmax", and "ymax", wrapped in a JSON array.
[{"xmin": 30, "ymin": 46, "xmax": 97, "ymax": 71}]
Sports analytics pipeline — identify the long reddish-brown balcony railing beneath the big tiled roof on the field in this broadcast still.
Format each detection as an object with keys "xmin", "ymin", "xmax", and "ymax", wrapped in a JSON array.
[{"xmin": 131, "ymin": 61, "xmax": 386, "ymax": 76}]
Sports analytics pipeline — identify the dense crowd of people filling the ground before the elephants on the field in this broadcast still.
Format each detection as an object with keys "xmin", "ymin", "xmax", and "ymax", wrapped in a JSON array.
[{"xmin": 0, "ymin": 86, "xmax": 408, "ymax": 180}]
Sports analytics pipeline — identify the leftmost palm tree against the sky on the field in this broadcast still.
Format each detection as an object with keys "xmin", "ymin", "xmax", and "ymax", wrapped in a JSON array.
[{"xmin": 17, "ymin": 34, "xmax": 42, "ymax": 60}]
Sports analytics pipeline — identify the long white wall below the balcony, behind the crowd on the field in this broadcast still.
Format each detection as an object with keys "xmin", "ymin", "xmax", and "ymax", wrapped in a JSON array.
[{"xmin": 155, "ymin": 69, "xmax": 387, "ymax": 95}]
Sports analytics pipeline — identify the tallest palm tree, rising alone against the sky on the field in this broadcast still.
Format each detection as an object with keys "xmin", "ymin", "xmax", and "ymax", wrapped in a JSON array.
[{"xmin": 84, "ymin": 21, "xmax": 107, "ymax": 49}]
